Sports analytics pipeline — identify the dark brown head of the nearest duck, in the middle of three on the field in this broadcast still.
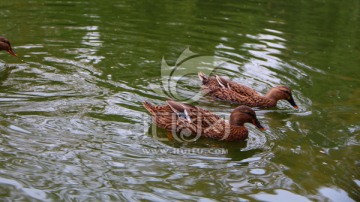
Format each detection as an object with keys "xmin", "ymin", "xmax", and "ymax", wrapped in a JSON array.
[{"xmin": 230, "ymin": 105, "xmax": 265, "ymax": 130}]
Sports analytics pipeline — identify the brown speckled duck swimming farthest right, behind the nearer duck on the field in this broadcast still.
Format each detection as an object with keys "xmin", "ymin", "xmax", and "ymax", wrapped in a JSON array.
[{"xmin": 198, "ymin": 72, "xmax": 298, "ymax": 109}]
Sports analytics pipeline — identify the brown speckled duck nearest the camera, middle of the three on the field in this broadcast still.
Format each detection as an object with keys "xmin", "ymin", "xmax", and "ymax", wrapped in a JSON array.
[{"xmin": 143, "ymin": 100, "xmax": 265, "ymax": 141}]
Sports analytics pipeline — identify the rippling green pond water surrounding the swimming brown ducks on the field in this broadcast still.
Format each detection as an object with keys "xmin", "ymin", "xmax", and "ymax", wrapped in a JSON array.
[{"xmin": 0, "ymin": 0, "xmax": 360, "ymax": 201}]
